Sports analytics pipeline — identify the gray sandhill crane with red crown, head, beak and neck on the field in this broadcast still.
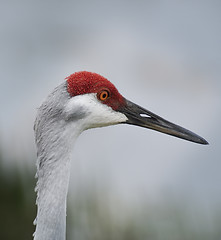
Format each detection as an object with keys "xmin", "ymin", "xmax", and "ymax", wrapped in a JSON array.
[{"xmin": 34, "ymin": 71, "xmax": 208, "ymax": 240}]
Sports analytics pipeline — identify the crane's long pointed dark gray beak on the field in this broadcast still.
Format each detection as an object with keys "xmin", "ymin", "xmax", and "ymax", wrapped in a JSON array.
[{"xmin": 118, "ymin": 99, "xmax": 208, "ymax": 144}]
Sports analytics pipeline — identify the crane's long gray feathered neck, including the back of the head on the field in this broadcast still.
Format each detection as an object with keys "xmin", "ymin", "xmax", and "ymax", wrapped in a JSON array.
[{"xmin": 34, "ymin": 84, "xmax": 80, "ymax": 240}]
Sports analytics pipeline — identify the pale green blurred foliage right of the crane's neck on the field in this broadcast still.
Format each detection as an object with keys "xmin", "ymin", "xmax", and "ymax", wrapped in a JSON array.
[{"xmin": 68, "ymin": 190, "xmax": 221, "ymax": 240}]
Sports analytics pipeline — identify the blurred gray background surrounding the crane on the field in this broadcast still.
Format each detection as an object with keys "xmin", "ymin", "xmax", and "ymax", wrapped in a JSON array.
[{"xmin": 0, "ymin": 0, "xmax": 221, "ymax": 240}]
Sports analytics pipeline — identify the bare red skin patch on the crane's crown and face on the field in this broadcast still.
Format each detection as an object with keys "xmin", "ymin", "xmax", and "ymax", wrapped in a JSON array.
[{"xmin": 66, "ymin": 71, "xmax": 125, "ymax": 110}]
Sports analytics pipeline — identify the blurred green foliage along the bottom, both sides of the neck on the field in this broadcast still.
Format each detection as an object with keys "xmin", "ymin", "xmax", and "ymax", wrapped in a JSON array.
[{"xmin": 0, "ymin": 148, "xmax": 221, "ymax": 240}]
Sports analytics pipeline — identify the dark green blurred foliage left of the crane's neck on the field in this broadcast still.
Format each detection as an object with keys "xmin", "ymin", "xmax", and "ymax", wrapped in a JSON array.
[{"xmin": 0, "ymin": 151, "xmax": 36, "ymax": 240}]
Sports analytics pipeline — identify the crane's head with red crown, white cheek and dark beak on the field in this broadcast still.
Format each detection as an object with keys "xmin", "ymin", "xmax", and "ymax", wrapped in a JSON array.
[{"xmin": 64, "ymin": 71, "xmax": 208, "ymax": 144}]
